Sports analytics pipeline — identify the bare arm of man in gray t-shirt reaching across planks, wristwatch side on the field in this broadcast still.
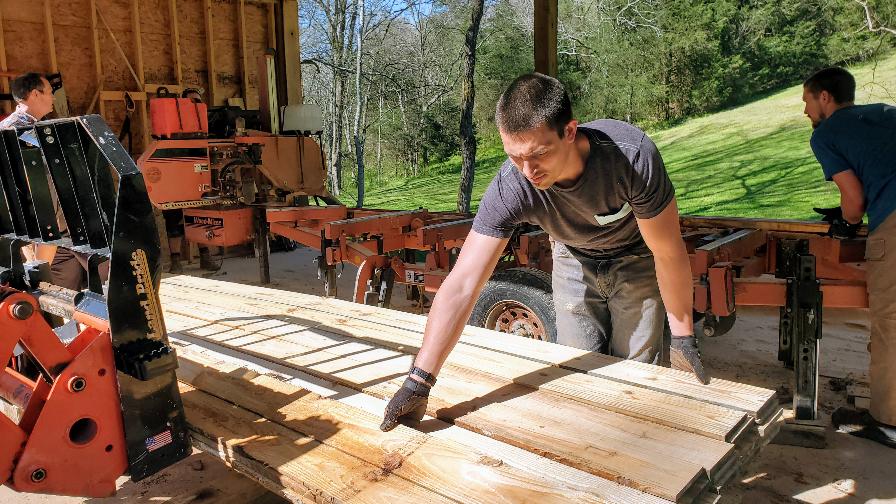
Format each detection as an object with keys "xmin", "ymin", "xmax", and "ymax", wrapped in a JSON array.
[{"xmin": 414, "ymin": 231, "xmax": 508, "ymax": 375}]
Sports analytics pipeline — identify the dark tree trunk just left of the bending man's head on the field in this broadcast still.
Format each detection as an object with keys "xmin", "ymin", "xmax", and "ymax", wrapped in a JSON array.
[{"xmin": 457, "ymin": 0, "xmax": 485, "ymax": 212}]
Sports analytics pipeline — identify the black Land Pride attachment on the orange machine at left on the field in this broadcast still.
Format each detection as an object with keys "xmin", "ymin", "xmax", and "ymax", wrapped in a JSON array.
[{"xmin": 0, "ymin": 115, "xmax": 191, "ymax": 481}]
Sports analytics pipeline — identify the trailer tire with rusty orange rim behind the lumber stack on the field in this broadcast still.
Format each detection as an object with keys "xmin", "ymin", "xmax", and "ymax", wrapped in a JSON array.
[{"xmin": 467, "ymin": 268, "xmax": 557, "ymax": 343}]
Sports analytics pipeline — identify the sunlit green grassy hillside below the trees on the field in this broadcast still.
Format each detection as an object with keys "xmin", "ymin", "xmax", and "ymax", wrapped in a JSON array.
[{"xmin": 343, "ymin": 55, "xmax": 896, "ymax": 218}]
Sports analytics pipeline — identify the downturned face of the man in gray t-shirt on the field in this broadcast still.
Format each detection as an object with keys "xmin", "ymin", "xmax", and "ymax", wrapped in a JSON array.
[{"xmin": 499, "ymin": 120, "xmax": 578, "ymax": 190}]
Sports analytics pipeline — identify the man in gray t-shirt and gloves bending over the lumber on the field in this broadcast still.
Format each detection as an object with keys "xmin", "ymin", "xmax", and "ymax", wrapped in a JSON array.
[{"xmin": 380, "ymin": 74, "xmax": 708, "ymax": 430}]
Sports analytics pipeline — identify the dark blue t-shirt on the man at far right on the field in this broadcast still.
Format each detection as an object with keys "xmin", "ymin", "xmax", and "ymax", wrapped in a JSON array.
[{"xmin": 809, "ymin": 103, "xmax": 896, "ymax": 231}]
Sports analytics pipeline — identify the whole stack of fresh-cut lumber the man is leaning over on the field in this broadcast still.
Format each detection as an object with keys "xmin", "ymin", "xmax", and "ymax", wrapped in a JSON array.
[{"xmin": 160, "ymin": 276, "xmax": 781, "ymax": 502}]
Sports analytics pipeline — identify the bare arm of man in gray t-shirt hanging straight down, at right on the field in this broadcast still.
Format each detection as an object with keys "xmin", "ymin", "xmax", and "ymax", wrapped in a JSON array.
[{"xmin": 637, "ymin": 199, "xmax": 694, "ymax": 336}]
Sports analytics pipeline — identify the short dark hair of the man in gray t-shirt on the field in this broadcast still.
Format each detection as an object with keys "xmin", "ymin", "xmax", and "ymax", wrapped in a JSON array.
[{"xmin": 495, "ymin": 72, "xmax": 572, "ymax": 138}]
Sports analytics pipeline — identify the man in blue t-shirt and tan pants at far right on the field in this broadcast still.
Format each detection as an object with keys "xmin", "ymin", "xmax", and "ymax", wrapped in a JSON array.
[{"xmin": 803, "ymin": 67, "xmax": 896, "ymax": 448}]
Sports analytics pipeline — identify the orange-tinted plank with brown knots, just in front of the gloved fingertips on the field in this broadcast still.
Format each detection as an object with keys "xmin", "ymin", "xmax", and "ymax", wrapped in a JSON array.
[{"xmin": 178, "ymin": 347, "xmax": 616, "ymax": 503}]
